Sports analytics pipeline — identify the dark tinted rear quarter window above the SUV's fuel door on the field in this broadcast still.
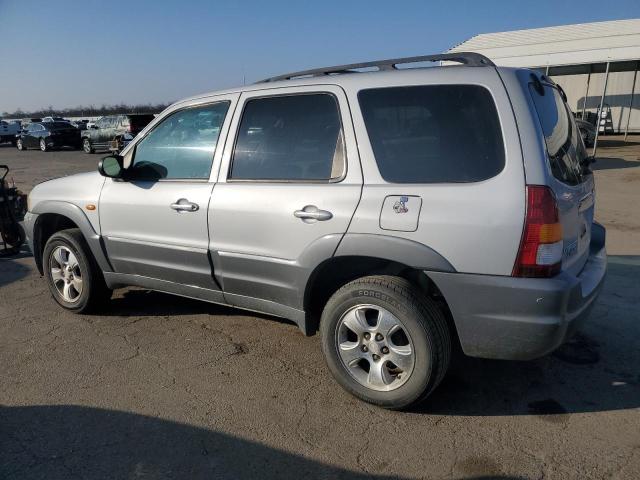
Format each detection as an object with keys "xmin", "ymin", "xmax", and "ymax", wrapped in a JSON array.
[{"xmin": 358, "ymin": 85, "xmax": 505, "ymax": 183}]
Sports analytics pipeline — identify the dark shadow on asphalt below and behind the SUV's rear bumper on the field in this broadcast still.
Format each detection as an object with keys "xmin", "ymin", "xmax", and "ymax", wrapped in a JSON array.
[{"xmin": 414, "ymin": 256, "xmax": 640, "ymax": 422}]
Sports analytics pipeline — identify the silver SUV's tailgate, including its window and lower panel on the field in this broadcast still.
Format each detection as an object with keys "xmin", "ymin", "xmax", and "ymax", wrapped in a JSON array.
[{"xmin": 529, "ymin": 83, "xmax": 595, "ymax": 275}]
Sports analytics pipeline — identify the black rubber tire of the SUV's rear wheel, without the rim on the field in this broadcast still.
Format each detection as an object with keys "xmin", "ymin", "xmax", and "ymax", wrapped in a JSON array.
[{"xmin": 320, "ymin": 276, "xmax": 451, "ymax": 409}]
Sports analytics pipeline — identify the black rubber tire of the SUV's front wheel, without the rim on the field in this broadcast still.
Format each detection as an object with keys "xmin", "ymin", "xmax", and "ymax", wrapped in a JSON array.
[{"xmin": 42, "ymin": 228, "xmax": 111, "ymax": 313}]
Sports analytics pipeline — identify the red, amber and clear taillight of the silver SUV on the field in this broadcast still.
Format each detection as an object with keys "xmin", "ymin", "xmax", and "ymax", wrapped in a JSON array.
[{"xmin": 513, "ymin": 185, "xmax": 562, "ymax": 277}]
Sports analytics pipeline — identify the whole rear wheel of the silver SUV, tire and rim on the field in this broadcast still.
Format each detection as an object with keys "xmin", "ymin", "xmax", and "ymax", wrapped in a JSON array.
[{"xmin": 320, "ymin": 276, "xmax": 451, "ymax": 409}]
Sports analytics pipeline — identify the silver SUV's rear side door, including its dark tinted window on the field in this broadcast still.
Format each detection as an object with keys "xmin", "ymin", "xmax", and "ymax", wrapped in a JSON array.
[{"xmin": 209, "ymin": 86, "xmax": 362, "ymax": 310}]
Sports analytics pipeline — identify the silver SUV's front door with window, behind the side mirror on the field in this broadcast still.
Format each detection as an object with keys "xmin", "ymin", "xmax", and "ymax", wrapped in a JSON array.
[{"xmin": 99, "ymin": 96, "xmax": 234, "ymax": 290}]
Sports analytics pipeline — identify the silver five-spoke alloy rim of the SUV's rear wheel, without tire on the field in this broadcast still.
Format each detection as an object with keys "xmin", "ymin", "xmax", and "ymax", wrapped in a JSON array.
[{"xmin": 335, "ymin": 305, "xmax": 415, "ymax": 392}]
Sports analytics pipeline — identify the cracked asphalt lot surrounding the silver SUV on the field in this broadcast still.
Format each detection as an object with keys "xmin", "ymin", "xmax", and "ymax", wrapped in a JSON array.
[{"xmin": 0, "ymin": 140, "xmax": 640, "ymax": 480}]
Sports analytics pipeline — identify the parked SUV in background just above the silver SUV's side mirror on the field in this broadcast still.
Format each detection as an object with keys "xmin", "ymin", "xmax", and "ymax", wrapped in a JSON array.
[{"xmin": 82, "ymin": 114, "xmax": 154, "ymax": 153}]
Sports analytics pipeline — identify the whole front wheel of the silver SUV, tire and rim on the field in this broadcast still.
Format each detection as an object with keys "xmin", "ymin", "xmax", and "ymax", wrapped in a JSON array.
[{"xmin": 42, "ymin": 228, "xmax": 111, "ymax": 313}]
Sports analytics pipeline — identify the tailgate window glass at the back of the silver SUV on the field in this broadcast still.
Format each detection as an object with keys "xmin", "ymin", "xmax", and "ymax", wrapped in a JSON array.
[{"xmin": 529, "ymin": 83, "xmax": 587, "ymax": 185}]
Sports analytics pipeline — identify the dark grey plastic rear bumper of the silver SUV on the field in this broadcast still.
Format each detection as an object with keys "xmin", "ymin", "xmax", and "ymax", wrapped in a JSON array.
[{"xmin": 429, "ymin": 223, "xmax": 607, "ymax": 360}]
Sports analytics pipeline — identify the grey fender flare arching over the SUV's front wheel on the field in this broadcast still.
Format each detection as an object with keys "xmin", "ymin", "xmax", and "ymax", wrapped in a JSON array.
[{"xmin": 31, "ymin": 200, "xmax": 113, "ymax": 273}]
